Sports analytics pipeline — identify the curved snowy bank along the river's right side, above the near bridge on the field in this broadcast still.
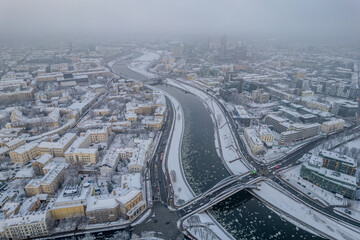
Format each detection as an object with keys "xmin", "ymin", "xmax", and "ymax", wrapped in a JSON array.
[{"xmin": 167, "ymin": 79, "xmax": 251, "ymax": 175}]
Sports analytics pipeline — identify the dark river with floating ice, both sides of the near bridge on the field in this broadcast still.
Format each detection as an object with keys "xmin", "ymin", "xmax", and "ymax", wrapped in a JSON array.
[{"xmin": 158, "ymin": 85, "xmax": 321, "ymax": 239}]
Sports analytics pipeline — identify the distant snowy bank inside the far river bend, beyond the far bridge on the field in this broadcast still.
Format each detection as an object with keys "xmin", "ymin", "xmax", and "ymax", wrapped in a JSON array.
[{"xmin": 128, "ymin": 51, "xmax": 160, "ymax": 78}]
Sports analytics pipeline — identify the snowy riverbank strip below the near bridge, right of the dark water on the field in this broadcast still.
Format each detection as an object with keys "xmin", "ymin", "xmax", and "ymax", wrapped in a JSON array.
[{"xmin": 254, "ymin": 182, "xmax": 360, "ymax": 240}]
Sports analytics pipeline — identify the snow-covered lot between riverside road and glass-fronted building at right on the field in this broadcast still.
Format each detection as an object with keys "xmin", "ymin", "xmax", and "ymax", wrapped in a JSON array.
[{"xmin": 282, "ymin": 165, "xmax": 347, "ymax": 206}]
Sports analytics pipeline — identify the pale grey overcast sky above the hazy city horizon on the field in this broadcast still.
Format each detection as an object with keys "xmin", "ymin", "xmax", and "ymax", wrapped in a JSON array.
[{"xmin": 0, "ymin": 0, "xmax": 360, "ymax": 38}]
